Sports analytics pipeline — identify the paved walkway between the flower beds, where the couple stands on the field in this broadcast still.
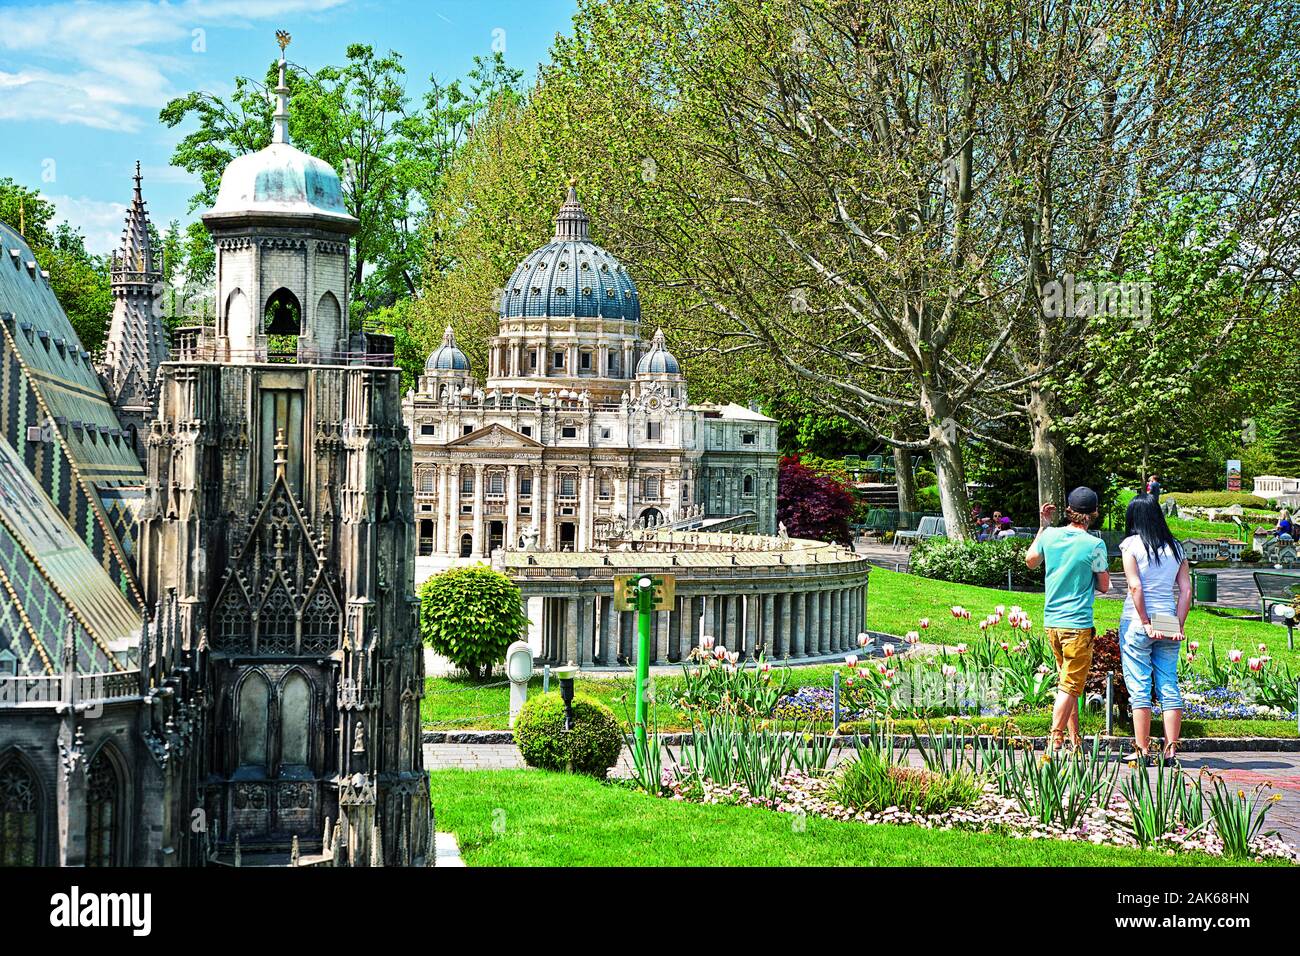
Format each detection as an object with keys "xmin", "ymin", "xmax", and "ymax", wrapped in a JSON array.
[{"xmin": 424, "ymin": 744, "xmax": 1300, "ymax": 844}]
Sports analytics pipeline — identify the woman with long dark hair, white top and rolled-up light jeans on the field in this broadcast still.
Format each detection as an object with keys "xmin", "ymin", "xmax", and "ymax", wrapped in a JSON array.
[{"xmin": 1119, "ymin": 494, "xmax": 1192, "ymax": 761}]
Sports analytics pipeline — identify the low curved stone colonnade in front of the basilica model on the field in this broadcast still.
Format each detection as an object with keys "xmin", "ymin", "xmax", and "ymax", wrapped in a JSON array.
[{"xmin": 494, "ymin": 528, "xmax": 871, "ymax": 667}]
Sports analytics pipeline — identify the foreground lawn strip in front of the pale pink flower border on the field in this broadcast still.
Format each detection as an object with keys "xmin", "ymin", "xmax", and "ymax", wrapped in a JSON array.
[{"xmin": 429, "ymin": 770, "xmax": 1253, "ymax": 866}]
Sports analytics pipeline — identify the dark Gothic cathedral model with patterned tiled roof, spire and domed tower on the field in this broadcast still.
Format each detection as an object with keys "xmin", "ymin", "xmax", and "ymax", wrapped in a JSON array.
[{"xmin": 0, "ymin": 35, "xmax": 433, "ymax": 866}]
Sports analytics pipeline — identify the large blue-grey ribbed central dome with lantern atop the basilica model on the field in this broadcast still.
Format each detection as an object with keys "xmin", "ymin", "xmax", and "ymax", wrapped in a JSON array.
[{"xmin": 501, "ymin": 185, "xmax": 641, "ymax": 323}]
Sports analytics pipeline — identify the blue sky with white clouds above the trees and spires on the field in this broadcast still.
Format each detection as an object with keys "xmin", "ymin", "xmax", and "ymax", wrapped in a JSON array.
[{"xmin": 0, "ymin": 0, "xmax": 576, "ymax": 252}]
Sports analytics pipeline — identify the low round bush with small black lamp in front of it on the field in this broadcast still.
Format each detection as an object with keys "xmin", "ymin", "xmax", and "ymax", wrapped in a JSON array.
[{"xmin": 515, "ymin": 693, "xmax": 623, "ymax": 778}]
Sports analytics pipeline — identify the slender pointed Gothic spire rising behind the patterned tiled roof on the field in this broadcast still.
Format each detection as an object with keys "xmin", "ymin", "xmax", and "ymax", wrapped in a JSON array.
[{"xmin": 100, "ymin": 163, "xmax": 168, "ymax": 463}]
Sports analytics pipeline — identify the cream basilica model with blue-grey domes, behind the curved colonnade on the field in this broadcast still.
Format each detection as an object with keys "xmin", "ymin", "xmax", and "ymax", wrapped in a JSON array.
[{"xmin": 404, "ymin": 185, "xmax": 779, "ymax": 559}]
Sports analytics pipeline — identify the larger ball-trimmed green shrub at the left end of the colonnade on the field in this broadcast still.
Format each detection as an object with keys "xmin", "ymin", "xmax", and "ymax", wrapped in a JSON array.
[{"xmin": 420, "ymin": 564, "xmax": 528, "ymax": 678}]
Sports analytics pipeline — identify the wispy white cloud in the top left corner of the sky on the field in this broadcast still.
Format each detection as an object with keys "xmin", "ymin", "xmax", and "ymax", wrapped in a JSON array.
[{"xmin": 0, "ymin": 0, "xmax": 348, "ymax": 133}]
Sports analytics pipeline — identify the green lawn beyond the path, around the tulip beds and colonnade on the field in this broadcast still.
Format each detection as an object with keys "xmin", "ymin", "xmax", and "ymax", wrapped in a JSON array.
[{"xmin": 421, "ymin": 568, "xmax": 1300, "ymax": 737}]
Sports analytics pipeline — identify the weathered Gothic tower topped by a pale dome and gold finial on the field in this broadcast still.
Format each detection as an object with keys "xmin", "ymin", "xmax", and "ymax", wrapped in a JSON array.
[{"xmin": 140, "ymin": 36, "xmax": 432, "ymax": 866}]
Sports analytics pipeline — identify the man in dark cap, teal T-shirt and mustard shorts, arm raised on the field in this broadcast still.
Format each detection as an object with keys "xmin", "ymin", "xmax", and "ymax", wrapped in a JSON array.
[{"xmin": 1024, "ymin": 488, "xmax": 1110, "ymax": 749}]
